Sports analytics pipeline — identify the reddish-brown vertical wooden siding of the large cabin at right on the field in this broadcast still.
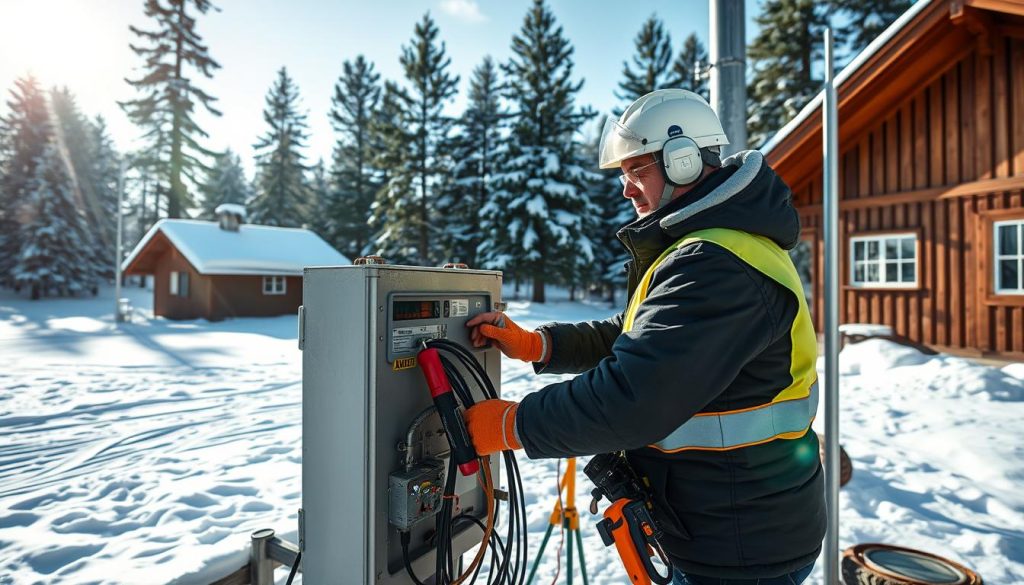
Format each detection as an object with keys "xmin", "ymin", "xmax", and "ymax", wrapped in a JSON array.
[{"xmin": 786, "ymin": 36, "xmax": 1024, "ymax": 358}]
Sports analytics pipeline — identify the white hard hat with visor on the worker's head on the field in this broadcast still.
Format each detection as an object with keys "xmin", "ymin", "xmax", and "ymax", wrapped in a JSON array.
[{"xmin": 598, "ymin": 89, "xmax": 729, "ymax": 169}]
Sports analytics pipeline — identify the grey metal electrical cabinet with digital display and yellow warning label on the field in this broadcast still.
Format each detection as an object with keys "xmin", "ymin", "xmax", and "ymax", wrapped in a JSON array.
[{"xmin": 299, "ymin": 264, "xmax": 502, "ymax": 585}]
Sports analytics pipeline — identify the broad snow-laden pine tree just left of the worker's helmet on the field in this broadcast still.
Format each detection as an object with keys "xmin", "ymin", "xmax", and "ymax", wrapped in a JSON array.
[{"xmin": 480, "ymin": 0, "xmax": 598, "ymax": 302}]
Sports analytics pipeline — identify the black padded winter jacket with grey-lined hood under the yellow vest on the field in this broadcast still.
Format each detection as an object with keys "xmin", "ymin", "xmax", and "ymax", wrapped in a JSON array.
[{"xmin": 516, "ymin": 151, "xmax": 825, "ymax": 579}]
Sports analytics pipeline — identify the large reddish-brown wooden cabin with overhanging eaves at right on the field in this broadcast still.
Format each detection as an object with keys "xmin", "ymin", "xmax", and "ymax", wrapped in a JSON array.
[{"xmin": 761, "ymin": 0, "xmax": 1024, "ymax": 360}]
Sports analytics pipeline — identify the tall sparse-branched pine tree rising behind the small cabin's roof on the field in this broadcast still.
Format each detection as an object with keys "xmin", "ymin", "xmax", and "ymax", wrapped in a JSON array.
[{"xmin": 121, "ymin": 0, "xmax": 220, "ymax": 217}]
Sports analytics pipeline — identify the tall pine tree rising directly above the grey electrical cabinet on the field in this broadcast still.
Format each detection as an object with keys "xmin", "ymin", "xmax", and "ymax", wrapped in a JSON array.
[{"xmin": 377, "ymin": 13, "xmax": 459, "ymax": 265}]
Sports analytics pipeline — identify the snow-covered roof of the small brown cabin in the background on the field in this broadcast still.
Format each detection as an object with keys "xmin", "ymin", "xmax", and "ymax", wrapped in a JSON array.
[{"xmin": 121, "ymin": 219, "xmax": 352, "ymax": 276}]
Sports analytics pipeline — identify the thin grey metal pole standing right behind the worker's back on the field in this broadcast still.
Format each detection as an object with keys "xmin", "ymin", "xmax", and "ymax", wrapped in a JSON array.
[{"xmin": 821, "ymin": 28, "xmax": 840, "ymax": 585}]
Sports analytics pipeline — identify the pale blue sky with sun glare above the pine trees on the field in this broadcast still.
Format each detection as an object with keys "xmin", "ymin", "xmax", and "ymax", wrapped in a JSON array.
[{"xmin": 0, "ymin": 0, "xmax": 758, "ymax": 176}]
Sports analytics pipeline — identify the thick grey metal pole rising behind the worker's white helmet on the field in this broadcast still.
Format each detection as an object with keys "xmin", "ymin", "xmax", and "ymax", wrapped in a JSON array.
[{"xmin": 708, "ymin": 0, "xmax": 746, "ymax": 157}]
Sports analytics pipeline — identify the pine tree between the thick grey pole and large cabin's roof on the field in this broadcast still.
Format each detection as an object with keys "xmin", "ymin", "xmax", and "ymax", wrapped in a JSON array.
[{"xmin": 746, "ymin": 0, "xmax": 827, "ymax": 147}]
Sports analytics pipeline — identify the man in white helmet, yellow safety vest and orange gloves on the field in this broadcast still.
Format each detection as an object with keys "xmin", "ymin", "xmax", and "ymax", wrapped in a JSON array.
[{"xmin": 466, "ymin": 89, "xmax": 825, "ymax": 585}]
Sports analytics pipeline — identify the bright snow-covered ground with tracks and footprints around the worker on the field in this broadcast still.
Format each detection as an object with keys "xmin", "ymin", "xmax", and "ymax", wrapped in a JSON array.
[{"xmin": 0, "ymin": 289, "xmax": 1024, "ymax": 585}]
